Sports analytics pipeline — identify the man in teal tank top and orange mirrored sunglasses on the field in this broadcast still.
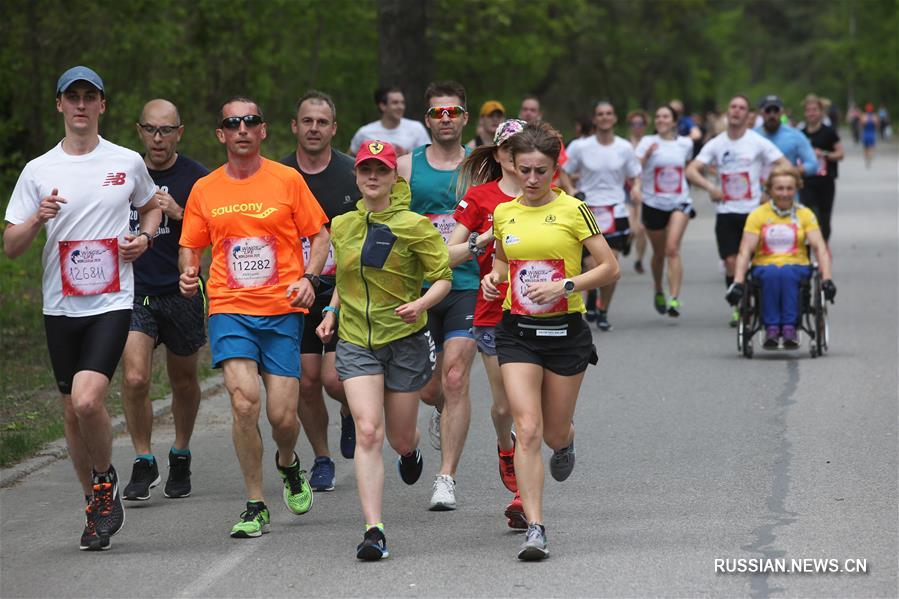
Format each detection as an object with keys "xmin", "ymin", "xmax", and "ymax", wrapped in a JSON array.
[{"xmin": 397, "ymin": 81, "xmax": 479, "ymax": 511}]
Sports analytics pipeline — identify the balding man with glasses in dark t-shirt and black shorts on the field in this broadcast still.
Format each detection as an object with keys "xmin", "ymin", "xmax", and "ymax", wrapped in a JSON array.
[{"xmin": 122, "ymin": 100, "xmax": 209, "ymax": 501}]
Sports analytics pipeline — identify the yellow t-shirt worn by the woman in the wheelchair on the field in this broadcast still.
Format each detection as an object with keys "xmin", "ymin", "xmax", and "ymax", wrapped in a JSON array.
[{"xmin": 743, "ymin": 202, "xmax": 820, "ymax": 266}]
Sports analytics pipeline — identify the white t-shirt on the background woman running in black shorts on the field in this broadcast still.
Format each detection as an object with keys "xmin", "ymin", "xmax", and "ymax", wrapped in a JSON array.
[{"xmin": 634, "ymin": 135, "xmax": 693, "ymax": 212}]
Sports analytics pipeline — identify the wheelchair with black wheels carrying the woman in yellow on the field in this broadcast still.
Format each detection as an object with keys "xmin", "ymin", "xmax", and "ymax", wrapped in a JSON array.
[{"xmin": 737, "ymin": 264, "xmax": 830, "ymax": 358}]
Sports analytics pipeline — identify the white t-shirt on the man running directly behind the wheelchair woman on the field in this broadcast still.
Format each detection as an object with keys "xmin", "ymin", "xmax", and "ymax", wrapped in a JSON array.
[{"xmin": 696, "ymin": 131, "xmax": 783, "ymax": 214}]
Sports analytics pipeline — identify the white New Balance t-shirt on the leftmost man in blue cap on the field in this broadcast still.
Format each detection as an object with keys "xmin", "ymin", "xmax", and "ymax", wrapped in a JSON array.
[{"xmin": 6, "ymin": 138, "xmax": 156, "ymax": 316}]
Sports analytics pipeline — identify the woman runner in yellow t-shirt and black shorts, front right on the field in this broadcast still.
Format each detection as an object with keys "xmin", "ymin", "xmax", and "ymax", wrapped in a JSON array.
[{"xmin": 482, "ymin": 125, "xmax": 627, "ymax": 560}]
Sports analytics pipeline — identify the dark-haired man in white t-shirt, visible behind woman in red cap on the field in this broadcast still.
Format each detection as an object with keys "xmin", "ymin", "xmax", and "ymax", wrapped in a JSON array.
[{"xmin": 349, "ymin": 87, "xmax": 431, "ymax": 156}]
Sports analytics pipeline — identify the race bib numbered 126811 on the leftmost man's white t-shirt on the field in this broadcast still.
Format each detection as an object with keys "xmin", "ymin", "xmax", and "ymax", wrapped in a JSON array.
[{"xmin": 59, "ymin": 238, "xmax": 119, "ymax": 296}]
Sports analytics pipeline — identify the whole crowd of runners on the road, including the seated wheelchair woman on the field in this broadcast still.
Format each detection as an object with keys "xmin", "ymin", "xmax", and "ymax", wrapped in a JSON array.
[{"xmin": 3, "ymin": 66, "xmax": 843, "ymax": 560}]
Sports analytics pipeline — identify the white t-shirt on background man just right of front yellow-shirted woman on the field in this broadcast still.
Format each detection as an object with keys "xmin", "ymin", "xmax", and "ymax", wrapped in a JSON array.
[{"xmin": 562, "ymin": 135, "xmax": 640, "ymax": 218}]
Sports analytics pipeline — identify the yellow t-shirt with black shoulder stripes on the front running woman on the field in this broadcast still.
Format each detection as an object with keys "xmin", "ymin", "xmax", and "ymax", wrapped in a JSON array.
[{"xmin": 493, "ymin": 190, "xmax": 601, "ymax": 316}]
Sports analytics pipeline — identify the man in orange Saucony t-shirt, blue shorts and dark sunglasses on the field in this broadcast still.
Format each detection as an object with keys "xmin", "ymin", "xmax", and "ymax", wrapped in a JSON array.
[{"xmin": 178, "ymin": 97, "xmax": 329, "ymax": 538}]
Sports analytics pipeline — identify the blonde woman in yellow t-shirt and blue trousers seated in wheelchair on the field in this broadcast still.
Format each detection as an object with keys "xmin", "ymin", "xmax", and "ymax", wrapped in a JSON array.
[{"xmin": 726, "ymin": 166, "xmax": 837, "ymax": 349}]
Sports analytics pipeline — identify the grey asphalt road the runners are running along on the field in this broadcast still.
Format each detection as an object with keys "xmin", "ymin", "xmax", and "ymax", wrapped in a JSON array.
[{"xmin": 0, "ymin": 142, "xmax": 899, "ymax": 597}]
